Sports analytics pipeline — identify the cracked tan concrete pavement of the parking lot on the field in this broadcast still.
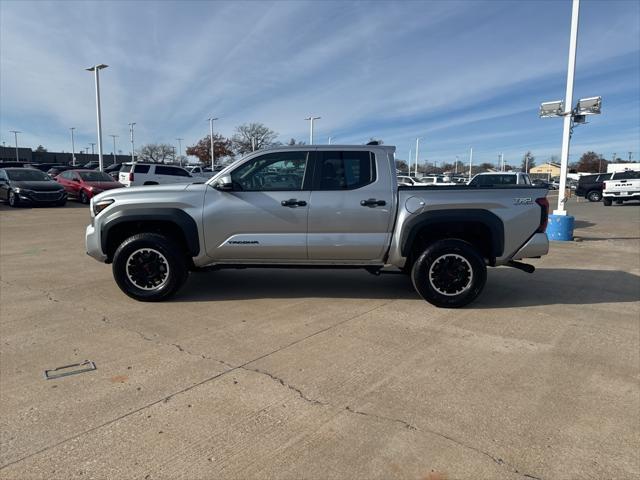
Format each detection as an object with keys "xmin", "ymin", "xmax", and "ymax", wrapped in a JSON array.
[{"xmin": 0, "ymin": 197, "xmax": 640, "ymax": 480}]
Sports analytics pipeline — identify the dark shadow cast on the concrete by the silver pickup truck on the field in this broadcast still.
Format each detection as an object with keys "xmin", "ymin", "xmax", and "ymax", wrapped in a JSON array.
[{"xmin": 173, "ymin": 267, "xmax": 640, "ymax": 309}]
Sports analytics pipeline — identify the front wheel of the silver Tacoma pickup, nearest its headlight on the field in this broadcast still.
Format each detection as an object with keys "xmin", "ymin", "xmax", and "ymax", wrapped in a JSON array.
[{"xmin": 113, "ymin": 233, "xmax": 189, "ymax": 302}]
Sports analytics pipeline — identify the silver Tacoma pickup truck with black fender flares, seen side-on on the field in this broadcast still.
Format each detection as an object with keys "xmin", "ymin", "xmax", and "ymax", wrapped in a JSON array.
[{"xmin": 86, "ymin": 145, "xmax": 549, "ymax": 307}]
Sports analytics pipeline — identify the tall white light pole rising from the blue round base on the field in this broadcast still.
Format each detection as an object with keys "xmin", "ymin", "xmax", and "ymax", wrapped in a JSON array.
[{"xmin": 553, "ymin": 0, "xmax": 580, "ymax": 216}]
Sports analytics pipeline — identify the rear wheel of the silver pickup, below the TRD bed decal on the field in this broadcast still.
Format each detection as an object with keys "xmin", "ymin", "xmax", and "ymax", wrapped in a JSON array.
[{"xmin": 411, "ymin": 239, "xmax": 487, "ymax": 308}]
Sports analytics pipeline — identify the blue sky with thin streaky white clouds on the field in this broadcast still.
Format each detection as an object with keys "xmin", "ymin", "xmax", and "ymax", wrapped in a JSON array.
[{"xmin": 0, "ymin": 0, "xmax": 640, "ymax": 164}]
